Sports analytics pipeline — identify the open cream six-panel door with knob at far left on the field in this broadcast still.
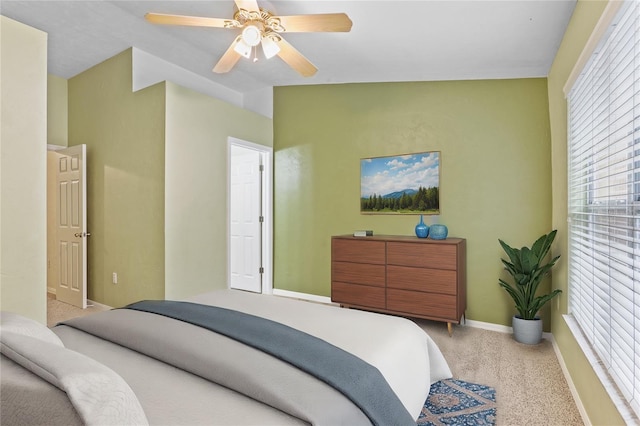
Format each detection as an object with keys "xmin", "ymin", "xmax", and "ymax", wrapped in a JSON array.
[{"xmin": 56, "ymin": 145, "xmax": 89, "ymax": 309}]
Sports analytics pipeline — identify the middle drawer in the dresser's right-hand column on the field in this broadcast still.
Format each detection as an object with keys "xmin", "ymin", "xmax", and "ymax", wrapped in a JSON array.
[{"xmin": 387, "ymin": 265, "xmax": 457, "ymax": 295}]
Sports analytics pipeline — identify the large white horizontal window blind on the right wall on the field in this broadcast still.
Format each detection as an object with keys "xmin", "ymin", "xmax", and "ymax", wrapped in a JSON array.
[{"xmin": 567, "ymin": 0, "xmax": 640, "ymax": 415}]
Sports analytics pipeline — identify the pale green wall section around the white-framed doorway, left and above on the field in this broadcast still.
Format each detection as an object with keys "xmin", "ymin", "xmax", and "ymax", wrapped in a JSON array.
[{"xmin": 165, "ymin": 82, "xmax": 273, "ymax": 299}]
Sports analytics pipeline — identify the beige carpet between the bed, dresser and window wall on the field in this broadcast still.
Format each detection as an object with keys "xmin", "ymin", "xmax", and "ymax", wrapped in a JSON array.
[{"xmin": 415, "ymin": 320, "xmax": 584, "ymax": 426}]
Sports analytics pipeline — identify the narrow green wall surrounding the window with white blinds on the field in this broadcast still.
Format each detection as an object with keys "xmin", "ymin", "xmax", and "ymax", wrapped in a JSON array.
[{"xmin": 548, "ymin": 1, "xmax": 624, "ymax": 425}]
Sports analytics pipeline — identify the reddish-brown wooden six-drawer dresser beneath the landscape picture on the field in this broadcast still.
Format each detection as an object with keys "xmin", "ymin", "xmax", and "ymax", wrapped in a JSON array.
[{"xmin": 331, "ymin": 235, "xmax": 467, "ymax": 334}]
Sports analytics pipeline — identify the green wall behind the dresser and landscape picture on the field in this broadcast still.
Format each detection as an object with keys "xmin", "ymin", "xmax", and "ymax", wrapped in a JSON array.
[{"xmin": 274, "ymin": 79, "xmax": 551, "ymax": 325}]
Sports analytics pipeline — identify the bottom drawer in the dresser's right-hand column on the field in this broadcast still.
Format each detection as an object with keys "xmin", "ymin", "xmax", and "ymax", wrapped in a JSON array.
[{"xmin": 387, "ymin": 289, "xmax": 462, "ymax": 322}]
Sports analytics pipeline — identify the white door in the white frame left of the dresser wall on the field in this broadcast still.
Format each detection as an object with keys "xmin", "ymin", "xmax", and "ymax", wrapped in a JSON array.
[{"xmin": 229, "ymin": 145, "xmax": 264, "ymax": 293}]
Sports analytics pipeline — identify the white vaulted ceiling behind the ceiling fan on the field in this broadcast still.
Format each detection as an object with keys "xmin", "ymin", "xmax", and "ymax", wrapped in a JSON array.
[{"xmin": 0, "ymin": 0, "xmax": 576, "ymax": 93}]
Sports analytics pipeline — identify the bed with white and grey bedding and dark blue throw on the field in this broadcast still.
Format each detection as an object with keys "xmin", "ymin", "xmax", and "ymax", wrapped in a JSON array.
[{"xmin": 0, "ymin": 290, "xmax": 451, "ymax": 425}]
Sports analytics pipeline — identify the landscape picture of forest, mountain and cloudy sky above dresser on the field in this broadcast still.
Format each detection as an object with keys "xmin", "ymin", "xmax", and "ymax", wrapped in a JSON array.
[{"xmin": 360, "ymin": 151, "xmax": 440, "ymax": 214}]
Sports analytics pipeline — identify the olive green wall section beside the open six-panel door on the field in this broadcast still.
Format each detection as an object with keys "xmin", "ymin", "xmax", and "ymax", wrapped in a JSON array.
[{"xmin": 68, "ymin": 49, "xmax": 165, "ymax": 307}]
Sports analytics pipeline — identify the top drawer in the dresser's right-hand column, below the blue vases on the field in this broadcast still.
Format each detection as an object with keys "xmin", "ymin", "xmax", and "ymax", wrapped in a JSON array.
[{"xmin": 387, "ymin": 242, "xmax": 457, "ymax": 270}]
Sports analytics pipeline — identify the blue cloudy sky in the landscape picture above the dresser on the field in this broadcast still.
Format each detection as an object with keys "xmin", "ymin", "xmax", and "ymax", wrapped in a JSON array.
[{"xmin": 360, "ymin": 151, "xmax": 440, "ymax": 197}]
